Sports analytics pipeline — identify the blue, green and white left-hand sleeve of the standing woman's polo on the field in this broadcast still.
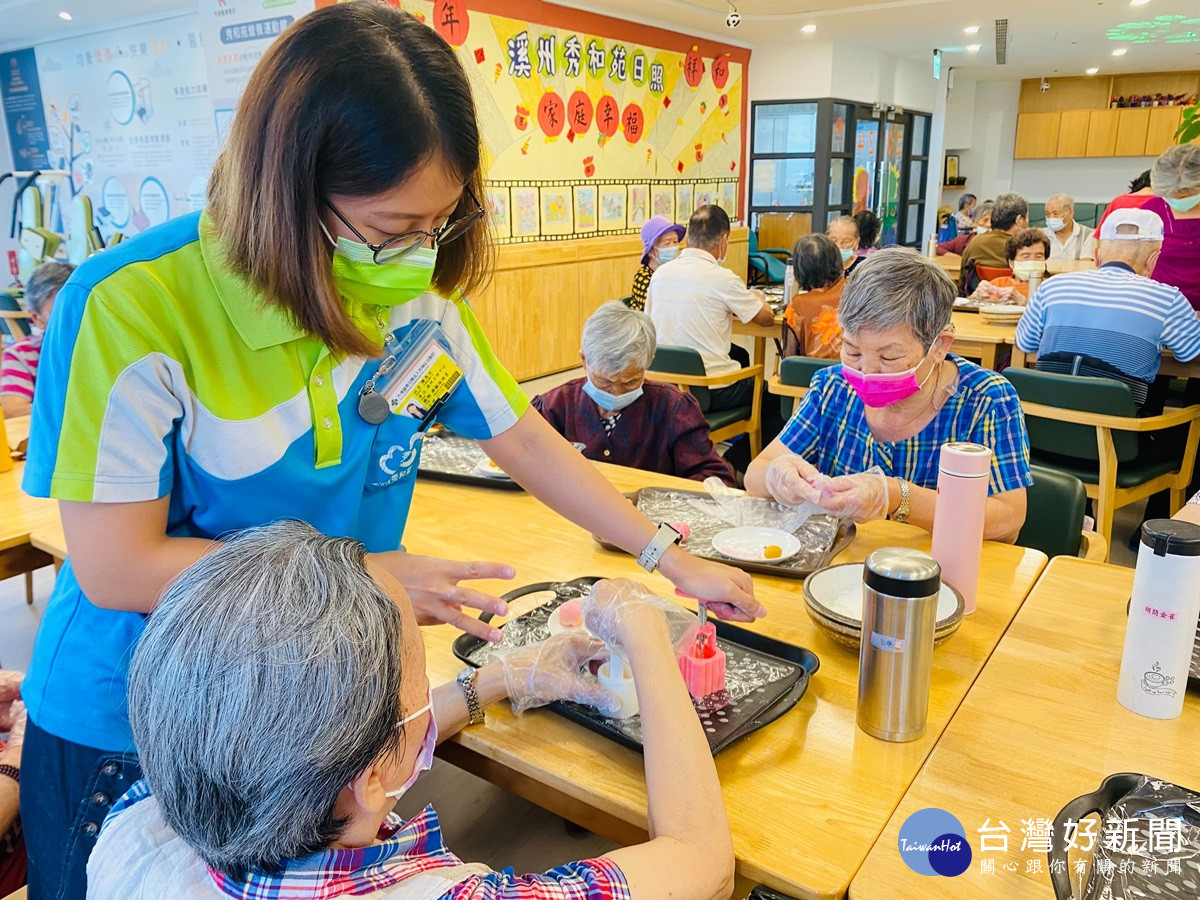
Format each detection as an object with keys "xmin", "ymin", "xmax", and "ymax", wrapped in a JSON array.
[{"xmin": 22, "ymin": 280, "xmax": 184, "ymax": 503}]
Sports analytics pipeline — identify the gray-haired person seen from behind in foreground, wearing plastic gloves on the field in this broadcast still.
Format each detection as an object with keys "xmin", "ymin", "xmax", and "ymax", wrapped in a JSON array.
[{"xmin": 88, "ymin": 522, "xmax": 733, "ymax": 900}]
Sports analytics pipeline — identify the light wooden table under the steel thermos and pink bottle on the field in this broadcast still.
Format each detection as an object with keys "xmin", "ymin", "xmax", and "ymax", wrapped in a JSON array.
[{"xmin": 23, "ymin": 464, "xmax": 1045, "ymax": 898}]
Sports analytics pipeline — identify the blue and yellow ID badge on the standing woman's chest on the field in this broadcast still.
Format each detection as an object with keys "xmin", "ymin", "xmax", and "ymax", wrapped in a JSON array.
[{"xmin": 359, "ymin": 319, "xmax": 463, "ymax": 427}]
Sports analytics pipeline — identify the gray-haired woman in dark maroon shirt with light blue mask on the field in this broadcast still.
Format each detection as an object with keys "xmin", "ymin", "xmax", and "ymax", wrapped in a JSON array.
[{"xmin": 533, "ymin": 300, "xmax": 734, "ymax": 486}]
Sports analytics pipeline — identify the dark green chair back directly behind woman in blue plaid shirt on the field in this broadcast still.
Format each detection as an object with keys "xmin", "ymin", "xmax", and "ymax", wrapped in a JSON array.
[{"xmin": 1016, "ymin": 466, "xmax": 1108, "ymax": 562}]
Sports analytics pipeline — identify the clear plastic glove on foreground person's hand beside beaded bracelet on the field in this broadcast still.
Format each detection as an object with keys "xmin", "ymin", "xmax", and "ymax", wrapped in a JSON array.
[{"xmin": 492, "ymin": 631, "xmax": 619, "ymax": 714}]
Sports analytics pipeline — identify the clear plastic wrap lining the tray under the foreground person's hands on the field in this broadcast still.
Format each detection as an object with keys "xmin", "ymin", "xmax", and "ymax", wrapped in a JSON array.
[{"xmin": 467, "ymin": 582, "xmax": 802, "ymax": 743}]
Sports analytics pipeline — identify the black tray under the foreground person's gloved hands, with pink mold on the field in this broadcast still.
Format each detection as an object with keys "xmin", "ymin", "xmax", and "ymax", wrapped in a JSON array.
[{"xmin": 454, "ymin": 577, "xmax": 821, "ymax": 756}]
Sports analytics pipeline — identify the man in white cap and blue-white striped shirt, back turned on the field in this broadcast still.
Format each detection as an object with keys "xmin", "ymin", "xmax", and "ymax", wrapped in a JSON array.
[{"xmin": 1016, "ymin": 209, "xmax": 1200, "ymax": 413}]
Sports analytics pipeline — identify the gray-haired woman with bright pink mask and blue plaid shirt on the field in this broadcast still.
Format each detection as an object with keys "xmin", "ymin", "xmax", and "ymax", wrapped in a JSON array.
[{"xmin": 746, "ymin": 248, "xmax": 1033, "ymax": 541}]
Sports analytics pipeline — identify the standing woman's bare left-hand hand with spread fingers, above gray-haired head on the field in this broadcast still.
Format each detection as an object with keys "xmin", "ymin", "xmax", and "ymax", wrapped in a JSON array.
[{"xmin": 368, "ymin": 551, "xmax": 516, "ymax": 643}]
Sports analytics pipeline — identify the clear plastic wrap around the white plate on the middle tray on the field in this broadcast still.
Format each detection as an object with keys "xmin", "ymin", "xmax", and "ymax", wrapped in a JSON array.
[{"xmin": 637, "ymin": 487, "xmax": 838, "ymax": 572}]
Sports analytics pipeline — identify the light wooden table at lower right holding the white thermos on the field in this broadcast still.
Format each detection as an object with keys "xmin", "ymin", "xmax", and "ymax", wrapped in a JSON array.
[{"xmin": 851, "ymin": 557, "xmax": 1200, "ymax": 900}]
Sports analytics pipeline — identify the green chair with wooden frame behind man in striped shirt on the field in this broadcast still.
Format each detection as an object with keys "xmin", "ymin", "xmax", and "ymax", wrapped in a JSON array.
[{"xmin": 1004, "ymin": 368, "xmax": 1200, "ymax": 556}]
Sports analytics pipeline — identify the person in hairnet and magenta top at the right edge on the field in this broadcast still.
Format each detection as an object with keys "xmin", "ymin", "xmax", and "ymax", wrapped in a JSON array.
[{"xmin": 1142, "ymin": 144, "xmax": 1200, "ymax": 310}]
